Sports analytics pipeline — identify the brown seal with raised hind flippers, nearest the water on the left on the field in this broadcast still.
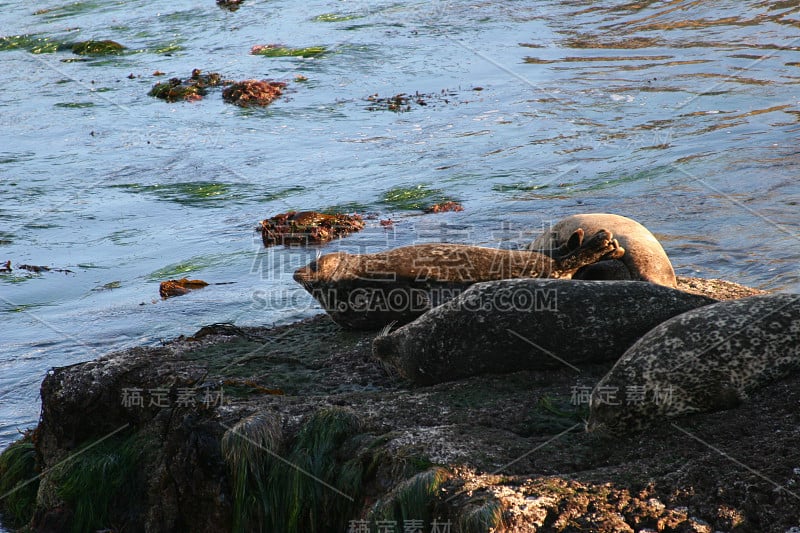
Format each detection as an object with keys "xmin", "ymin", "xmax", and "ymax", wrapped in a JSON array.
[{"xmin": 294, "ymin": 229, "xmax": 625, "ymax": 329}]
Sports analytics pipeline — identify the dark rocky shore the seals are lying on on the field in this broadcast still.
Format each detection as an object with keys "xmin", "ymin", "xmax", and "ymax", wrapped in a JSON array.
[{"xmin": 0, "ymin": 278, "xmax": 800, "ymax": 533}]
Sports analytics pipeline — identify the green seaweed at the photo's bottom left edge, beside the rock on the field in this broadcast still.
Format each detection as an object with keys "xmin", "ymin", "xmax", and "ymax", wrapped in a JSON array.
[{"xmin": 0, "ymin": 432, "xmax": 39, "ymax": 527}]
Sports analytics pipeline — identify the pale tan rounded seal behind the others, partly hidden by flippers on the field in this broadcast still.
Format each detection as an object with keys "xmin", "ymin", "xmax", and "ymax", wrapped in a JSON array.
[{"xmin": 528, "ymin": 213, "xmax": 676, "ymax": 287}]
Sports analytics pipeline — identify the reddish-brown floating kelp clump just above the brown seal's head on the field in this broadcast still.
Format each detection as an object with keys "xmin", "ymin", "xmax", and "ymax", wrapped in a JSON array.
[{"xmin": 260, "ymin": 211, "xmax": 364, "ymax": 246}]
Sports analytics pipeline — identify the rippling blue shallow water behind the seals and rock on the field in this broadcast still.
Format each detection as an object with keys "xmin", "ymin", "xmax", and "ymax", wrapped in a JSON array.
[{"xmin": 0, "ymin": 0, "xmax": 800, "ymax": 486}]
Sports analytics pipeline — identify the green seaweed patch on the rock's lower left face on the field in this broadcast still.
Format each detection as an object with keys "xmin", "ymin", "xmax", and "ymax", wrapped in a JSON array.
[{"xmin": 48, "ymin": 433, "xmax": 146, "ymax": 533}]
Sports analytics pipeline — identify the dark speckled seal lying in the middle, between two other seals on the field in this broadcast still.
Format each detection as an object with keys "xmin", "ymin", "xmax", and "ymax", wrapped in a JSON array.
[{"xmin": 372, "ymin": 279, "xmax": 716, "ymax": 384}]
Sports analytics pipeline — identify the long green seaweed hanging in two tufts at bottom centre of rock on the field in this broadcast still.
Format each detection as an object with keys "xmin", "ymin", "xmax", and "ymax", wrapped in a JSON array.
[{"xmin": 222, "ymin": 408, "xmax": 364, "ymax": 533}]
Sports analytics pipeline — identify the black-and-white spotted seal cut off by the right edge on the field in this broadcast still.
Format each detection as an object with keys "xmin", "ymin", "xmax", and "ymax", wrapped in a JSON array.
[{"xmin": 587, "ymin": 294, "xmax": 800, "ymax": 432}]
